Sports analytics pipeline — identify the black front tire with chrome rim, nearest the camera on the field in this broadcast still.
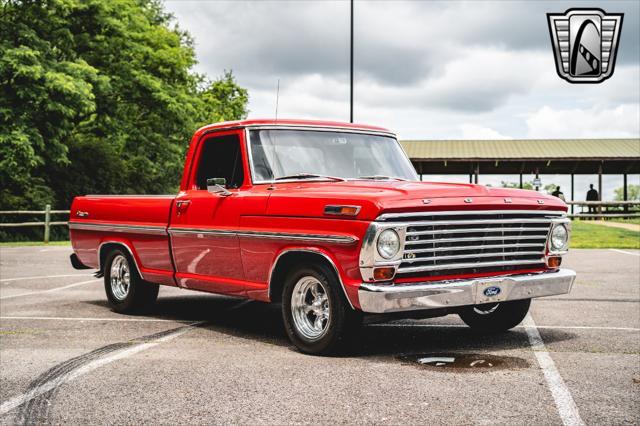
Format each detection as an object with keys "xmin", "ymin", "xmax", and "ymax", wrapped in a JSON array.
[{"xmin": 282, "ymin": 265, "xmax": 357, "ymax": 355}]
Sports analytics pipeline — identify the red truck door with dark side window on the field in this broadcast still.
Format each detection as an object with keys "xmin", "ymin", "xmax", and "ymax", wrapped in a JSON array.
[{"xmin": 169, "ymin": 132, "xmax": 248, "ymax": 295}]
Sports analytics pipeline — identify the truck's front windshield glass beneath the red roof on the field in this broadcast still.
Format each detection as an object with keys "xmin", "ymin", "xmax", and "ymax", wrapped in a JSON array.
[{"xmin": 250, "ymin": 130, "xmax": 417, "ymax": 183}]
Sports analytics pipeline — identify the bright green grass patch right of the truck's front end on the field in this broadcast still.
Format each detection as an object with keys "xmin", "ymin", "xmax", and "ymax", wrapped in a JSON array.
[{"xmin": 570, "ymin": 220, "xmax": 640, "ymax": 249}]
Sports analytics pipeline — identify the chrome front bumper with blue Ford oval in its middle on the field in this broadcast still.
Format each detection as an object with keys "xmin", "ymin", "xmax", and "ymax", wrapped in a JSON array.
[{"xmin": 358, "ymin": 269, "xmax": 576, "ymax": 313}]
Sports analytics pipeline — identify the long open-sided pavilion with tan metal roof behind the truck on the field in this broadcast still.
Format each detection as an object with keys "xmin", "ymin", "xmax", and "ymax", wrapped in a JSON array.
[{"xmin": 400, "ymin": 138, "xmax": 640, "ymax": 206}]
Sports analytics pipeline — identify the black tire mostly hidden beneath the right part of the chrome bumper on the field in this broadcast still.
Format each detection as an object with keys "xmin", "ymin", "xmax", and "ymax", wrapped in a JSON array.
[{"xmin": 458, "ymin": 299, "xmax": 531, "ymax": 333}]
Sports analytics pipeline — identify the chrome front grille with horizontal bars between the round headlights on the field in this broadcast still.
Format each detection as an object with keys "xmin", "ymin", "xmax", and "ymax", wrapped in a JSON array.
[{"xmin": 378, "ymin": 210, "xmax": 563, "ymax": 278}]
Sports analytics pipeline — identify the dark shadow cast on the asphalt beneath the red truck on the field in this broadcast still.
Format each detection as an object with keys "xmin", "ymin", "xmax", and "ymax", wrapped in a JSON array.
[{"xmin": 85, "ymin": 295, "xmax": 576, "ymax": 358}]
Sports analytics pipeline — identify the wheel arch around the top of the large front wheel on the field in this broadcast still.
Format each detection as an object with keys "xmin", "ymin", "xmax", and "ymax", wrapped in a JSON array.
[{"xmin": 268, "ymin": 248, "xmax": 355, "ymax": 309}]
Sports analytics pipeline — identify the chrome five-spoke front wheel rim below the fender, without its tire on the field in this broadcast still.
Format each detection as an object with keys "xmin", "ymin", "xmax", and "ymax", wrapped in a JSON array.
[{"xmin": 291, "ymin": 276, "xmax": 331, "ymax": 340}]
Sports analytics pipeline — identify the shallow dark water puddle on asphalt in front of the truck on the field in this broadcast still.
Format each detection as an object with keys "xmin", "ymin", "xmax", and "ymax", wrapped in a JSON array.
[{"xmin": 398, "ymin": 354, "xmax": 529, "ymax": 371}]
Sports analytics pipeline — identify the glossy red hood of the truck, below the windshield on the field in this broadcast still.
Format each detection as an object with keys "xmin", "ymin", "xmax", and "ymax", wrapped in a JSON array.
[{"xmin": 267, "ymin": 180, "xmax": 567, "ymax": 220}]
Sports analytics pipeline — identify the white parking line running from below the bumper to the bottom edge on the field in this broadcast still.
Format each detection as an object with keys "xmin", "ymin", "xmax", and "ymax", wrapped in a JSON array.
[{"xmin": 523, "ymin": 314, "xmax": 584, "ymax": 426}]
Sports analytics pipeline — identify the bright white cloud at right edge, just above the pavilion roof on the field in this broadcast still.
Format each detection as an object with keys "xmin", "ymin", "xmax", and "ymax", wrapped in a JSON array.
[{"xmin": 526, "ymin": 104, "xmax": 640, "ymax": 139}]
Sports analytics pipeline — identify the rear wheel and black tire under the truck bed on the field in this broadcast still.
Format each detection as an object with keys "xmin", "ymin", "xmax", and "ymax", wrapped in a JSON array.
[{"xmin": 104, "ymin": 248, "xmax": 159, "ymax": 314}]
